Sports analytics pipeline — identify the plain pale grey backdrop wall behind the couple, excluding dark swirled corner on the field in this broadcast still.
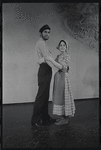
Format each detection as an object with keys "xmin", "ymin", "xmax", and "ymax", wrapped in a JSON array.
[{"xmin": 2, "ymin": 3, "xmax": 99, "ymax": 104}]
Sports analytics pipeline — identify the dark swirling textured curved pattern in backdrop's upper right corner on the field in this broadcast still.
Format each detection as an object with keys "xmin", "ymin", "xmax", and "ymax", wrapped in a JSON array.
[{"xmin": 55, "ymin": 3, "xmax": 99, "ymax": 52}]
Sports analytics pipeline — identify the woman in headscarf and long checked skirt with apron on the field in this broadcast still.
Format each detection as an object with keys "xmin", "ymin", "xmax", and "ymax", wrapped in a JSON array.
[{"xmin": 53, "ymin": 40, "xmax": 75, "ymax": 125}]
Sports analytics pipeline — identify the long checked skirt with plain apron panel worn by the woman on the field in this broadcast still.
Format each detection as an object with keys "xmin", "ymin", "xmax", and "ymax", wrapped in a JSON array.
[{"xmin": 53, "ymin": 70, "xmax": 75, "ymax": 116}]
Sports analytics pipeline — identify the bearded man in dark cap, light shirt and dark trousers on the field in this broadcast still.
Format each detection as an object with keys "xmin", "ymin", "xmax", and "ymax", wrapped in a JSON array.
[{"xmin": 31, "ymin": 25, "xmax": 62, "ymax": 127}]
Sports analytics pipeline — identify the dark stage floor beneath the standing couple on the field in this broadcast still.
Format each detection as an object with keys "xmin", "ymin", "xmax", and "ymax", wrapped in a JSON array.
[{"xmin": 2, "ymin": 99, "xmax": 99, "ymax": 149}]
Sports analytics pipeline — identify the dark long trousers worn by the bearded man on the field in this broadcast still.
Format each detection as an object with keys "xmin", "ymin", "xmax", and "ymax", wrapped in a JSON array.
[{"xmin": 31, "ymin": 63, "xmax": 52, "ymax": 125}]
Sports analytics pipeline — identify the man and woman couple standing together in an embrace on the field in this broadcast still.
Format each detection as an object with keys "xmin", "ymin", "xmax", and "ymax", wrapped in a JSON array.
[{"xmin": 31, "ymin": 25, "xmax": 75, "ymax": 127}]
